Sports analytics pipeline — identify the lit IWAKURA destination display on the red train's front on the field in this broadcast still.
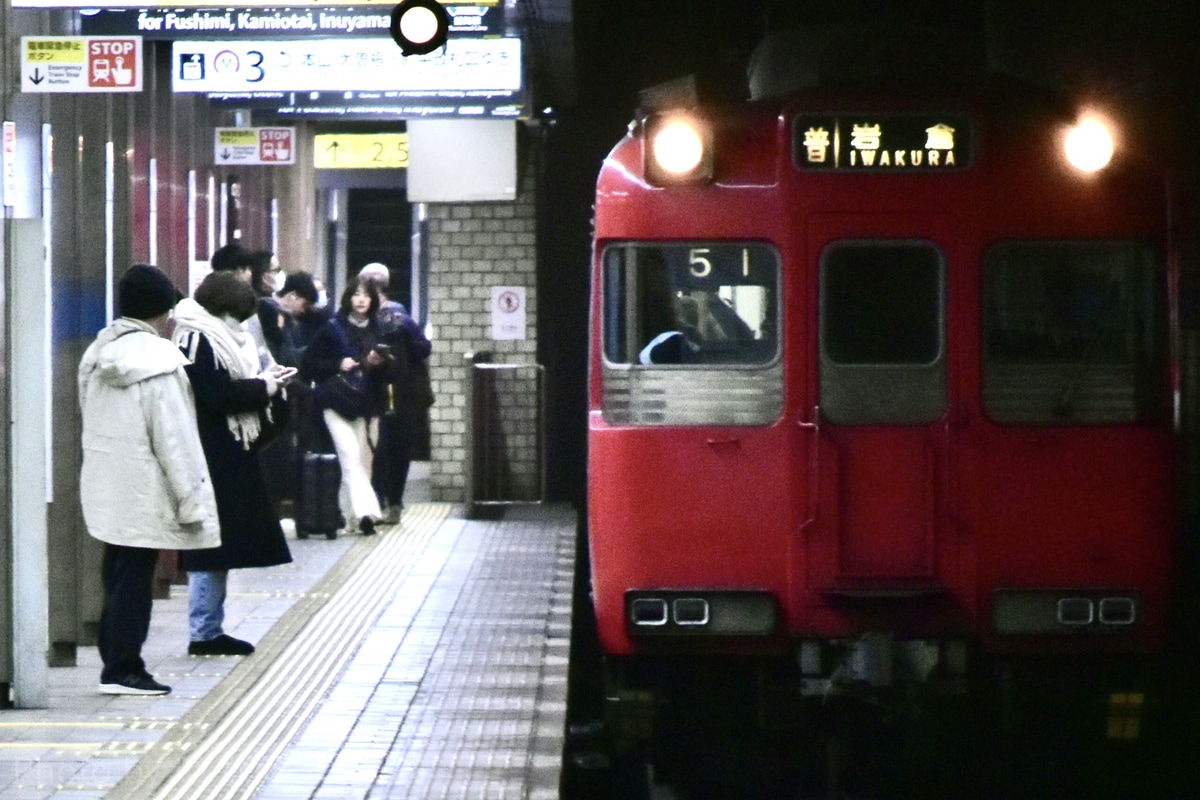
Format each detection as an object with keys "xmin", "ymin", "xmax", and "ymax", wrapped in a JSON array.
[{"xmin": 792, "ymin": 113, "xmax": 972, "ymax": 173}]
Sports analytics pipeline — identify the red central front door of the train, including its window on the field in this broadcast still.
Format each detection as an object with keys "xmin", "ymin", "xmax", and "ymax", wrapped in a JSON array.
[{"xmin": 808, "ymin": 215, "xmax": 953, "ymax": 593}]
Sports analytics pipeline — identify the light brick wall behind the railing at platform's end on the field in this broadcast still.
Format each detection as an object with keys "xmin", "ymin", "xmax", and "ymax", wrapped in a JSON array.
[{"xmin": 427, "ymin": 158, "xmax": 540, "ymax": 503}]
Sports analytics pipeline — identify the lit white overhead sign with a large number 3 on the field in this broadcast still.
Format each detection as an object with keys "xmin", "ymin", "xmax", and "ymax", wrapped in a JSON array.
[{"xmin": 170, "ymin": 38, "xmax": 521, "ymax": 95}]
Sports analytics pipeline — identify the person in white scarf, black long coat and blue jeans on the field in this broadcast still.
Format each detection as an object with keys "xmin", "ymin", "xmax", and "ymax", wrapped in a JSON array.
[{"xmin": 172, "ymin": 272, "xmax": 295, "ymax": 656}]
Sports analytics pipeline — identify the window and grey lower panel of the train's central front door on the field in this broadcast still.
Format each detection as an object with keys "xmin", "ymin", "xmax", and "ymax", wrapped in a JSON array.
[{"xmin": 820, "ymin": 240, "xmax": 946, "ymax": 425}]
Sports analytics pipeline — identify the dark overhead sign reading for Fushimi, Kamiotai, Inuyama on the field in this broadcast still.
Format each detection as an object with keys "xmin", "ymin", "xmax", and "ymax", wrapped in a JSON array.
[{"xmin": 79, "ymin": 4, "xmax": 504, "ymax": 41}]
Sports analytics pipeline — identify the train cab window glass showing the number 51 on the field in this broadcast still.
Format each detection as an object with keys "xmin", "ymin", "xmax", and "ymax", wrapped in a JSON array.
[{"xmin": 604, "ymin": 242, "xmax": 779, "ymax": 367}]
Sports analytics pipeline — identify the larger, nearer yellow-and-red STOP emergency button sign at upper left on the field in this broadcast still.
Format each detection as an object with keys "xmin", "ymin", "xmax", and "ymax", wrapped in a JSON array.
[{"xmin": 20, "ymin": 36, "xmax": 142, "ymax": 92}]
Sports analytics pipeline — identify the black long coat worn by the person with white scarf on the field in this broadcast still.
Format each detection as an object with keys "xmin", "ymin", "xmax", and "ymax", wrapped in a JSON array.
[{"xmin": 179, "ymin": 335, "xmax": 292, "ymax": 572}]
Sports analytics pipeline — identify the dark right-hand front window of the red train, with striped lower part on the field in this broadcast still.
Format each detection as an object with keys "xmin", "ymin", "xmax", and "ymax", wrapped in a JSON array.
[{"xmin": 983, "ymin": 242, "xmax": 1169, "ymax": 425}]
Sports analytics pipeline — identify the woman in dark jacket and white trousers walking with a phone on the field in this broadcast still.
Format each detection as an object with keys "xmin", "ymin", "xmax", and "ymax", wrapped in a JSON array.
[{"xmin": 300, "ymin": 278, "xmax": 391, "ymax": 536}]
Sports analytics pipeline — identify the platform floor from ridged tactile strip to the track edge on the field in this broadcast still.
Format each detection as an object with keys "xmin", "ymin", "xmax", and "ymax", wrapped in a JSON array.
[{"xmin": 107, "ymin": 505, "xmax": 576, "ymax": 800}]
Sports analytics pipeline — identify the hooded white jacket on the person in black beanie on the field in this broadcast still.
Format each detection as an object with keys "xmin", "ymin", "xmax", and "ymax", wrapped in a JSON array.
[{"xmin": 79, "ymin": 317, "xmax": 221, "ymax": 549}]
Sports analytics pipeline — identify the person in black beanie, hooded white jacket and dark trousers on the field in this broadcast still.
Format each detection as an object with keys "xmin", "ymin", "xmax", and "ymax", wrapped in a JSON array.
[{"xmin": 79, "ymin": 264, "xmax": 221, "ymax": 694}]
